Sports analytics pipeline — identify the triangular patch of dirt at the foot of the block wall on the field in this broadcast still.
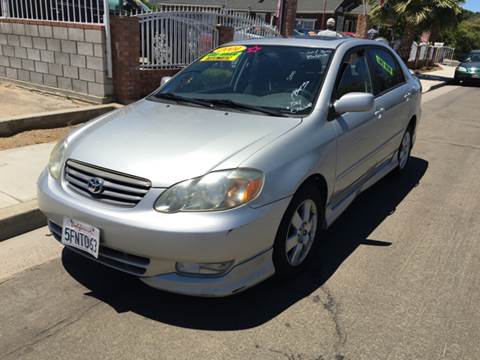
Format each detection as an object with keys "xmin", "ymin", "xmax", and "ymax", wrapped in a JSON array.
[{"xmin": 0, "ymin": 81, "xmax": 91, "ymax": 120}]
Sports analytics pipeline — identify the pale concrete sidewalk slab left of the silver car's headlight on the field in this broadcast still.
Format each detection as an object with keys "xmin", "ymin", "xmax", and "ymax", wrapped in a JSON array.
[{"xmin": 0, "ymin": 143, "xmax": 55, "ymax": 209}]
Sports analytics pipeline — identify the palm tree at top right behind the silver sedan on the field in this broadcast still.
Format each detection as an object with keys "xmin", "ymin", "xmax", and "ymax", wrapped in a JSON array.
[{"xmin": 371, "ymin": 0, "xmax": 464, "ymax": 60}]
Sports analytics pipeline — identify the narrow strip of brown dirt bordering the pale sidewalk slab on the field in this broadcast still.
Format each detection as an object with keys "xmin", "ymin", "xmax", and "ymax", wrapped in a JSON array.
[{"xmin": 0, "ymin": 125, "xmax": 78, "ymax": 151}]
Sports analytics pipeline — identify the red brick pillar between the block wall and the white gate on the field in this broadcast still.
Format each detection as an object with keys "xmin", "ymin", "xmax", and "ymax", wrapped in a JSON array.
[{"xmin": 110, "ymin": 16, "xmax": 140, "ymax": 103}]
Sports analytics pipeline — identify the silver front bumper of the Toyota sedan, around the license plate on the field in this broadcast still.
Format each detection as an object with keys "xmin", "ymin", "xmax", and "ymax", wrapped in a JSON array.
[{"xmin": 38, "ymin": 171, "xmax": 290, "ymax": 296}]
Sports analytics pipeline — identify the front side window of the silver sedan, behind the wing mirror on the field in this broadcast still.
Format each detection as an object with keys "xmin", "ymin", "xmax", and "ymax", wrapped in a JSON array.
[{"xmin": 335, "ymin": 50, "xmax": 373, "ymax": 100}]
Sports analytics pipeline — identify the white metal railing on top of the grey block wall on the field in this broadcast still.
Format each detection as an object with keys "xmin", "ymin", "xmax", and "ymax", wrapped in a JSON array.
[{"xmin": 0, "ymin": 0, "xmax": 105, "ymax": 24}]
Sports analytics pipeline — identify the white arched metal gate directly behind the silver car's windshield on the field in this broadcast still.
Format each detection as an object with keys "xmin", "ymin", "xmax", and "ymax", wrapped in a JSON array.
[{"xmin": 132, "ymin": 5, "xmax": 279, "ymax": 69}]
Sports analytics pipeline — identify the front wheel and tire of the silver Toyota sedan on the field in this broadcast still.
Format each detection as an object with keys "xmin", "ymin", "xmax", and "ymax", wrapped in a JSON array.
[{"xmin": 273, "ymin": 184, "xmax": 323, "ymax": 279}]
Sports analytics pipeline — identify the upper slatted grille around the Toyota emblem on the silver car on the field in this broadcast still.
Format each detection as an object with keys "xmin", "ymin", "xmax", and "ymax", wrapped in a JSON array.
[{"xmin": 65, "ymin": 160, "xmax": 151, "ymax": 207}]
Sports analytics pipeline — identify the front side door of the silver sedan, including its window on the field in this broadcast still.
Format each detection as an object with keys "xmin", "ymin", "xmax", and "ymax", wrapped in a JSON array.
[{"xmin": 330, "ymin": 48, "xmax": 378, "ymax": 202}]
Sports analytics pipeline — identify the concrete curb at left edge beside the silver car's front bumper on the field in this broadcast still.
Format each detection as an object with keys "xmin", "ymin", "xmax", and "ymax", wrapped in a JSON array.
[{"xmin": 0, "ymin": 199, "xmax": 47, "ymax": 242}]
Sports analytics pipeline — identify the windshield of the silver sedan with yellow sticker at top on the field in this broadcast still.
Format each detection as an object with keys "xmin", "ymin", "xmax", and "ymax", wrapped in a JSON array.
[{"xmin": 153, "ymin": 45, "xmax": 333, "ymax": 116}]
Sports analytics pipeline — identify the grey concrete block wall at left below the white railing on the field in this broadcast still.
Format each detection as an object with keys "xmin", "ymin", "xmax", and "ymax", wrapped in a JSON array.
[{"xmin": 0, "ymin": 19, "xmax": 113, "ymax": 102}]
